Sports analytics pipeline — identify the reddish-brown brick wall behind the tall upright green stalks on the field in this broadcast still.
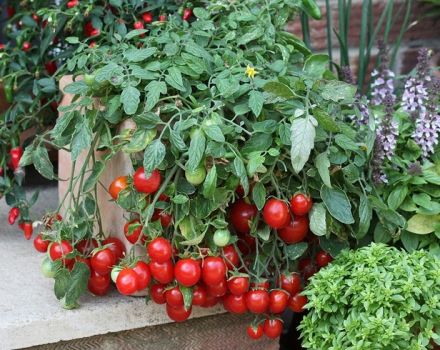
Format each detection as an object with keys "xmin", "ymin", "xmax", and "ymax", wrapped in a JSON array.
[{"xmin": 288, "ymin": 0, "xmax": 440, "ymax": 78}]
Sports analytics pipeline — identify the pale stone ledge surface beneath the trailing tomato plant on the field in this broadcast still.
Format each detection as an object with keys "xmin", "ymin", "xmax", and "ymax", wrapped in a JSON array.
[{"xmin": 0, "ymin": 187, "xmax": 221, "ymax": 349}]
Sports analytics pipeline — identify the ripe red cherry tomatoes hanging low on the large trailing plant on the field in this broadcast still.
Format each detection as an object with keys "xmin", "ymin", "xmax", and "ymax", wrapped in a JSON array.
[{"xmin": 29, "ymin": 162, "xmax": 332, "ymax": 339}]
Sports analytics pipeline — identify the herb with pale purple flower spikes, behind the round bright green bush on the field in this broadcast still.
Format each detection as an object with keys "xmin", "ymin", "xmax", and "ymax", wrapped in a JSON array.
[{"xmin": 372, "ymin": 49, "xmax": 440, "ymax": 255}]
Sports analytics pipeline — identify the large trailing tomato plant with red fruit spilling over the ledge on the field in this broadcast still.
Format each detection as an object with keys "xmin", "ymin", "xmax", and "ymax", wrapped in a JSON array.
[{"xmin": 1, "ymin": 0, "xmax": 412, "ymax": 339}]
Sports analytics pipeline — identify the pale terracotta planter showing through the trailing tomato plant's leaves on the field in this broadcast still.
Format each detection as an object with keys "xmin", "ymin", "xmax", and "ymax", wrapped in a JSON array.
[{"xmin": 58, "ymin": 76, "xmax": 147, "ymax": 296}]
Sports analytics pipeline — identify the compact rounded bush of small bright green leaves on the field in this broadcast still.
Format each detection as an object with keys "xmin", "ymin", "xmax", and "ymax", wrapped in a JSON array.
[{"xmin": 300, "ymin": 244, "xmax": 440, "ymax": 350}]
